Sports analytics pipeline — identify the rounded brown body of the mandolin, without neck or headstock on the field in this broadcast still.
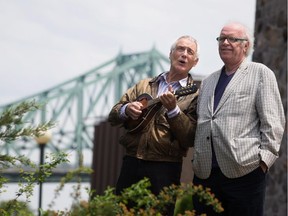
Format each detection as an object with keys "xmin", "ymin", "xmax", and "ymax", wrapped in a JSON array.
[{"xmin": 124, "ymin": 93, "xmax": 162, "ymax": 133}]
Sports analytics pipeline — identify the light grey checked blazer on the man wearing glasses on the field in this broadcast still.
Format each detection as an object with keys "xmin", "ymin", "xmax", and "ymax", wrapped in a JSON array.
[{"xmin": 192, "ymin": 61, "xmax": 285, "ymax": 179}]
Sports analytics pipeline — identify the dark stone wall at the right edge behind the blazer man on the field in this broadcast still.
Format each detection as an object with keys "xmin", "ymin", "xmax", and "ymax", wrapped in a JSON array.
[{"xmin": 252, "ymin": 0, "xmax": 287, "ymax": 216}]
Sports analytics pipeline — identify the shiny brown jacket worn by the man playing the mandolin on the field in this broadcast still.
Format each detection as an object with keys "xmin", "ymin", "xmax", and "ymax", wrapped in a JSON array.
[{"xmin": 108, "ymin": 74, "xmax": 198, "ymax": 162}]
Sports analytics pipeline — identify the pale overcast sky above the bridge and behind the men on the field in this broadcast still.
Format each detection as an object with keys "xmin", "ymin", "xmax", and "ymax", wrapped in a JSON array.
[{"xmin": 0, "ymin": 0, "xmax": 256, "ymax": 213}]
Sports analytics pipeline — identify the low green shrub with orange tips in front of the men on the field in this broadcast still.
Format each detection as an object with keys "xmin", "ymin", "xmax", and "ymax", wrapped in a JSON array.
[{"xmin": 44, "ymin": 178, "xmax": 223, "ymax": 216}]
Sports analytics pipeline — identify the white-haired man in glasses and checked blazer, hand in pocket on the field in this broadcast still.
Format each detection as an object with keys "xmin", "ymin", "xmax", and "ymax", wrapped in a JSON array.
[{"xmin": 192, "ymin": 22, "xmax": 285, "ymax": 216}]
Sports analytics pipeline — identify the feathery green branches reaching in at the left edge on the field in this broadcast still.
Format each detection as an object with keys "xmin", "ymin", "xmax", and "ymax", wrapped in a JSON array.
[{"xmin": 0, "ymin": 101, "xmax": 68, "ymax": 216}]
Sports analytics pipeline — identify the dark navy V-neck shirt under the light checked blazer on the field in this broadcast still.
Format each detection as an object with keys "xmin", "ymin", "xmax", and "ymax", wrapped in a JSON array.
[{"xmin": 212, "ymin": 67, "xmax": 235, "ymax": 167}]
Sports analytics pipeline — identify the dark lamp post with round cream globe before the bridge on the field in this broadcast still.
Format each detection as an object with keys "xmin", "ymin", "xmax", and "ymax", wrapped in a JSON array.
[{"xmin": 35, "ymin": 130, "xmax": 52, "ymax": 215}]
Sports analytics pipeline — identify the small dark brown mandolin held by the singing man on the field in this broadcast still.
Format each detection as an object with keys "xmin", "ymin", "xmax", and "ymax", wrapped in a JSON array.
[{"xmin": 124, "ymin": 84, "xmax": 198, "ymax": 133}]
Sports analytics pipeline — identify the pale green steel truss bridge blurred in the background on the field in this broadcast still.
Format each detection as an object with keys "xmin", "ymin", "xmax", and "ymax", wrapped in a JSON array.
[{"xmin": 0, "ymin": 48, "xmax": 169, "ymax": 179}]
